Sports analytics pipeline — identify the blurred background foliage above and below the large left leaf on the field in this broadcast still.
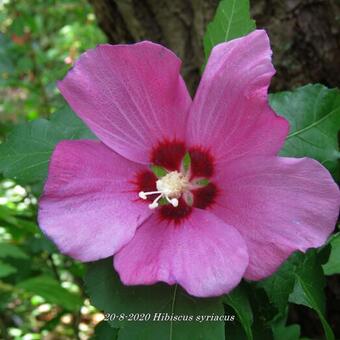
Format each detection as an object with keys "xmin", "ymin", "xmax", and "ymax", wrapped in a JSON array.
[{"xmin": 0, "ymin": 0, "xmax": 106, "ymax": 340}]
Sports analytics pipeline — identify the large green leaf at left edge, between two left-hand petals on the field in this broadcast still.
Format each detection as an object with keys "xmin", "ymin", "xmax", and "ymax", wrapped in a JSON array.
[{"xmin": 0, "ymin": 107, "xmax": 94, "ymax": 184}]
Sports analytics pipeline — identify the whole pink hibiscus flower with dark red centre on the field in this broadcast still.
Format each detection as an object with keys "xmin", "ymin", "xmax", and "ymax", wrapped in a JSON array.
[{"xmin": 39, "ymin": 30, "xmax": 339, "ymax": 296}]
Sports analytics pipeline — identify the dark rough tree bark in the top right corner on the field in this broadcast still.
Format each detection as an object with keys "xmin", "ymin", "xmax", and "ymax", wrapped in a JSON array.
[{"xmin": 252, "ymin": 0, "xmax": 340, "ymax": 91}]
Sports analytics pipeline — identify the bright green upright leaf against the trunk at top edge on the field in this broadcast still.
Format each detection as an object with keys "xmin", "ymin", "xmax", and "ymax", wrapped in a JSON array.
[{"xmin": 203, "ymin": 0, "xmax": 256, "ymax": 60}]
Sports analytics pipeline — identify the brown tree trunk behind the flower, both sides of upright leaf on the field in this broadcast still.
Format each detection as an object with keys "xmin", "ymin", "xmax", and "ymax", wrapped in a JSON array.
[{"xmin": 89, "ymin": 0, "xmax": 340, "ymax": 93}]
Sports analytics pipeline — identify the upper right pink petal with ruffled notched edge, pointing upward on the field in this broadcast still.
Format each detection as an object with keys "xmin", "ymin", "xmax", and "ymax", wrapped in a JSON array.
[{"xmin": 188, "ymin": 30, "xmax": 288, "ymax": 160}]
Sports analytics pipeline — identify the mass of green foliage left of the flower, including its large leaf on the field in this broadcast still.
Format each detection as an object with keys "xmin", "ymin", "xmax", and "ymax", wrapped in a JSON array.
[{"xmin": 0, "ymin": 0, "xmax": 105, "ymax": 340}]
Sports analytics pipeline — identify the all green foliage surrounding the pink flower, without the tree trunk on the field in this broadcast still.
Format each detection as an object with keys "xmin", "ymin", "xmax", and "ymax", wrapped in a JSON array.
[{"xmin": 0, "ymin": 0, "xmax": 340, "ymax": 340}]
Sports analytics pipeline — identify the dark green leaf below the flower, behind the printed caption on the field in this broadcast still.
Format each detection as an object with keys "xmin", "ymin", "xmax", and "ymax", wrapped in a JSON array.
[{"xmin": 85, "ymin": 258, "xmax": 224, "ymax": 340}]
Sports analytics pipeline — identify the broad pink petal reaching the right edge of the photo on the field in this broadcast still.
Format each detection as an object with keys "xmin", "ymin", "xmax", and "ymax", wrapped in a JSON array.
[{"xmin": 212, "ymin": 157, "xmax": 340, "ymax": 280}]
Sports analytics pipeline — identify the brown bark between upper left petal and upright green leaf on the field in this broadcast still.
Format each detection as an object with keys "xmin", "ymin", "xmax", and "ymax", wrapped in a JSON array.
[{"xmin": 90, "ymin": 0, "xmax": 218, "ymax": 91}]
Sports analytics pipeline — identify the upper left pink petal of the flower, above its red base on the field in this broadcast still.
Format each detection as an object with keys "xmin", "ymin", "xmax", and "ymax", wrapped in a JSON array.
[{"xmin": 58, "ymin": 41, "xmax": 191, "ymax": 163}]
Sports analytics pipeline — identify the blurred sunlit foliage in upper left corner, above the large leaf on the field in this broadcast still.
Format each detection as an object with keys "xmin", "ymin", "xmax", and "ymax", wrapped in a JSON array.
[{"xmin": 0, "ymin": 0, "xmax": 106, "ymax": 122}]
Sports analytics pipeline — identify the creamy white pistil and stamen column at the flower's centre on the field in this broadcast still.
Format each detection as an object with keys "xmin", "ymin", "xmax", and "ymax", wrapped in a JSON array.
[{"xmin": 138, "ymin": 171, "xmax": 188, "ymax": 209}]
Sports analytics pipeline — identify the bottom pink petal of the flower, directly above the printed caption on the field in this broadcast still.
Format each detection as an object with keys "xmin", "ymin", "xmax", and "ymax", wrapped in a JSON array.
[{"xmin": 114, "ymin": 209, "xmax": 248, "ymax": 297}]
